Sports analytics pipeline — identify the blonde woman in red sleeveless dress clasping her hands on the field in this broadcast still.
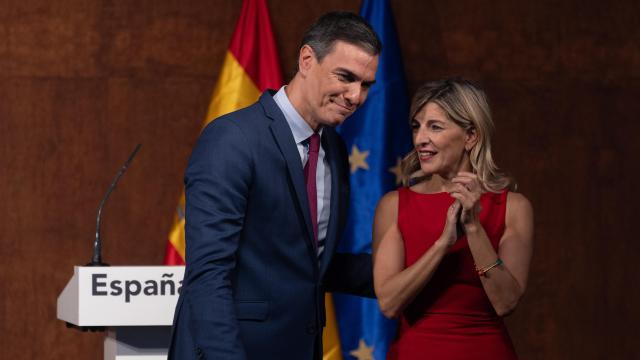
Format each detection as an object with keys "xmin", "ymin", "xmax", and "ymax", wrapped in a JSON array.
[{"xmin": 373, "ymin": 79, "xmax": 533, "ymax": 360}]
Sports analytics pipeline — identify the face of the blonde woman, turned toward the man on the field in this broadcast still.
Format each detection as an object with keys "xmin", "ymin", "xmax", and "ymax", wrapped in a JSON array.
[{"xmin": 411, "ymin": 103, "xmax": 476, "ymax": 179}]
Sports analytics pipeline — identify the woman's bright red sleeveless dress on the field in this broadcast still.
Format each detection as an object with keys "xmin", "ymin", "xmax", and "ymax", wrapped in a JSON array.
[{"xmin": 387, "ymin": 187, "xmax": 517, "ymax": 360}]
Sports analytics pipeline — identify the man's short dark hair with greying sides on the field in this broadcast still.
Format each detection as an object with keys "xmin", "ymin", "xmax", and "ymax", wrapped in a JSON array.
[{"xmin": 300, "ymin": 11, "xmax": 382, "ymax": 62}]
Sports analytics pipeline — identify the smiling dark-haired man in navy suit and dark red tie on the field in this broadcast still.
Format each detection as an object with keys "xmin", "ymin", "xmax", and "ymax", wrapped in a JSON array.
[{"xmin": 169, "ymin": 12, "xmax": 381, "ymax": 360}]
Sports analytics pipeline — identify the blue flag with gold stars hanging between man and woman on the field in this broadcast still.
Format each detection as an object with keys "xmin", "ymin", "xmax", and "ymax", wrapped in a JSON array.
[{"xmin": 333, "ymin": 0, "xmax": 411, "ymax": 360}]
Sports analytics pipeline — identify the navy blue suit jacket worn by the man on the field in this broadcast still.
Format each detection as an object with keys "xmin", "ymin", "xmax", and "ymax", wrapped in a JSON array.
[{"xmin": 169, "ymin": 92, "xmax": 373, "ymax": 360}]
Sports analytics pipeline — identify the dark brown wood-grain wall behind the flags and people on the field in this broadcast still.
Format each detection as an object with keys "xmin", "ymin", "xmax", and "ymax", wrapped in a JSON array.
[{"xmin": 0, "ymin": 0, "xmax": 640, "ymax": 359}]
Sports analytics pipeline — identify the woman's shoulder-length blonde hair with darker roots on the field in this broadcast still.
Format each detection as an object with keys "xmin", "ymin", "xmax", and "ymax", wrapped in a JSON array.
[{"xmin": 402, "ymin": 79, "xmax": 514, "ymax": 192}]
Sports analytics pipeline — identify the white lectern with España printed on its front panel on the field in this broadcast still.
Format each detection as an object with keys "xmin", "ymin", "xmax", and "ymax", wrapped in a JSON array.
[{"xmin": 58, "ymin": 266, "xmax": 184, "ymax": 360}]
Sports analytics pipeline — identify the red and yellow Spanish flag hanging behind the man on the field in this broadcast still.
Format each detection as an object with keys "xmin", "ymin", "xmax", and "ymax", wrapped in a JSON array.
[{"xmin": 164, "ymin": 0, "xmax": 342, "ymax": 360}]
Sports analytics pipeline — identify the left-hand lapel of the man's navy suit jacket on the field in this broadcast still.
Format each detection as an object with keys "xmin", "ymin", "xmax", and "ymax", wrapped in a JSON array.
[{"xmin": 260, "ymin": 92, "xmax": 317, "ymax": 263}]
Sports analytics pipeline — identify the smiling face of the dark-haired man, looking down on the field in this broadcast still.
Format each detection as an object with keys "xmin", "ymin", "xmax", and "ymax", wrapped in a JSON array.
[{"xmin": 300, "ymin": 41, "xmax": 378, "ymax": 130}]
